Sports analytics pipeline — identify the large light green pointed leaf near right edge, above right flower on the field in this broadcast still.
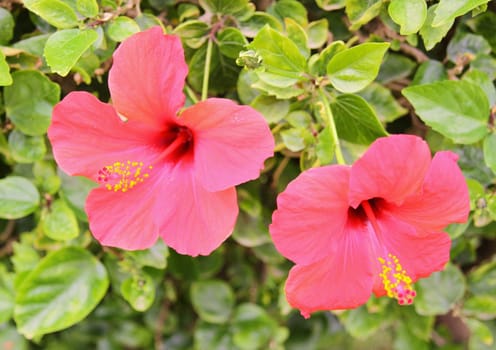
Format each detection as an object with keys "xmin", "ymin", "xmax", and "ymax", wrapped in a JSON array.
[{"xmin": 402, "ymin": 81, "xmax": 489, "ymax": 144}]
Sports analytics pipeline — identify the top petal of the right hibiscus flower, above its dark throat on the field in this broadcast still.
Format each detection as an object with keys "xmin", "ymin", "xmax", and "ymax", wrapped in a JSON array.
[{"xmin": 349, "ymin": 135, "xmax": 431, "ymax": 208}]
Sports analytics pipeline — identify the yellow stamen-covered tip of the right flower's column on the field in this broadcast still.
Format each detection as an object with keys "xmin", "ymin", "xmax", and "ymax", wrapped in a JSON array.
[{"xmin": 378, "ymin": 254, "xmax": 417, "ymax": 305}]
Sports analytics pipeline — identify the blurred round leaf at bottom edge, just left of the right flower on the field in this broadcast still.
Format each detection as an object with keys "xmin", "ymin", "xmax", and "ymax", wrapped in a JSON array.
[{"xmin": 231, "ymin": 303, "xmax": 277, "ymax": 350}]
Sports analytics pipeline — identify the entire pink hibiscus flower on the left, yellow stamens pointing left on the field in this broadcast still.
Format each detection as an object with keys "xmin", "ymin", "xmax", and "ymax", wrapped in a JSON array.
[{"xmin": 48, "ymin": 27, "xmax": 274, "ymax": 256}]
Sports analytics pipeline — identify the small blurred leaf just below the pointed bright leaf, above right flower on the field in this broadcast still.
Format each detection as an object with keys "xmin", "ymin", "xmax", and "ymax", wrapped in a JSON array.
[{"xmin": 358, "ymin": 83, "xmax": 408, "ymax": 122}]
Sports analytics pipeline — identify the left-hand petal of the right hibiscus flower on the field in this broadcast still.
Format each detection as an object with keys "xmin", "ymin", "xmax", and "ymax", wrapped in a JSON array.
[{"xmin": 269, "ymin": 165, "xmax": 350, "ymax": 264}]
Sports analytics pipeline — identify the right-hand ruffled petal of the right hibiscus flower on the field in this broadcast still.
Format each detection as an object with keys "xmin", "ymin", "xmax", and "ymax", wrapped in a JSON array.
[{"xmin": 386, "ymin": 151, "xmax": 470, "ymax": 232}]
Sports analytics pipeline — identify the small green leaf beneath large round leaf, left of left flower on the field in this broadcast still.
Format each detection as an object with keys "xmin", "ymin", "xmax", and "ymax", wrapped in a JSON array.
[{"xmin": 9, "ymin": 130, "xmax": 46, "ymax": 163}]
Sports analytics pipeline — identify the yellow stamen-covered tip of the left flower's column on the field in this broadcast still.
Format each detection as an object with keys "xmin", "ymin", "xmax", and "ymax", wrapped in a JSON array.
[{"xmin": 97, "ymin": 160, "xmax": 153, "ymax": 192}]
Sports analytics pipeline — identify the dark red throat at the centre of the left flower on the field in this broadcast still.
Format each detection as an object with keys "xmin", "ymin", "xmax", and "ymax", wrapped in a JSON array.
[{"xmin": 160, "ymin": 125, "xmax": 193, "ymax": 162}]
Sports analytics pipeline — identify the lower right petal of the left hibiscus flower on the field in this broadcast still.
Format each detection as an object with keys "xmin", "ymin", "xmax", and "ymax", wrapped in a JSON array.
[{"xmin": 154, "ymin": 164, "xmax": 238, "ymax": 256}]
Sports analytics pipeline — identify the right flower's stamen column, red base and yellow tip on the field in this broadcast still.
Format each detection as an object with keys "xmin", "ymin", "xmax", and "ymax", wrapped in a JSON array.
[{"xmin": 360, "ymin": 201, "xmax": 417, "ymax": 305}]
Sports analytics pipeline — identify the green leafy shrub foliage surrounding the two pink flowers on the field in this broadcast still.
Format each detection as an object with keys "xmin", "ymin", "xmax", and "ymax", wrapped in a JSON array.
[{"xmin": 0, "ymin": 0, "xmax": 496, "ymax": 350}]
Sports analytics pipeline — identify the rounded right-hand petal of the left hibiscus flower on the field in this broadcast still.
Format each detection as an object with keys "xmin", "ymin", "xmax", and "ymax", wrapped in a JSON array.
[{"xmin": 179, "ymin": 98, "xmax": 274, "ymax": 191}]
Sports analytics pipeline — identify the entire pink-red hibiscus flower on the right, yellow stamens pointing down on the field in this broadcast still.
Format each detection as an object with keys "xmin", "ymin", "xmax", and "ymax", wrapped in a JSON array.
[{"xmin": 270, "ymin": 135, "xmax": 469, "ymax": 317}]
